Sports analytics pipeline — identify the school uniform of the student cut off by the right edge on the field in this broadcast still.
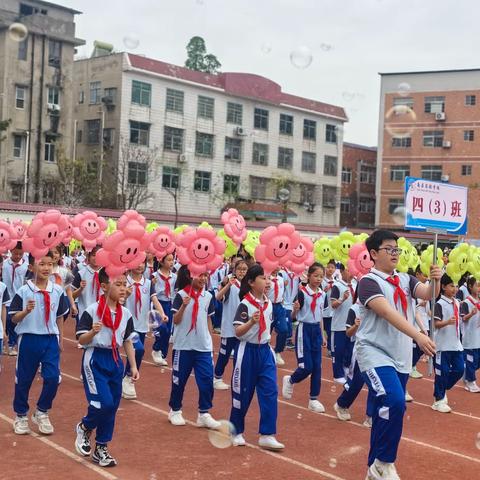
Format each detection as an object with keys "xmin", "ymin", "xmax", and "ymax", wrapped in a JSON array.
[{"xmin": 460, "ymin": 295, "xmax": 480, "ymax": 382}]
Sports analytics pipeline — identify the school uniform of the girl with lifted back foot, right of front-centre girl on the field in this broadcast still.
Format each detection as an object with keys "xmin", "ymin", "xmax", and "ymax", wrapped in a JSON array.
[{"xmin": 290, "ymin": 285, "xmax": 325, "ymax": 400}]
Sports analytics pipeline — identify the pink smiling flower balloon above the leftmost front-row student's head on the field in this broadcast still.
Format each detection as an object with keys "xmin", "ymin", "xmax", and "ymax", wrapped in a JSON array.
[{"xmin": 23, "ymin": 210, "xmax": 67, "ymax": 259}]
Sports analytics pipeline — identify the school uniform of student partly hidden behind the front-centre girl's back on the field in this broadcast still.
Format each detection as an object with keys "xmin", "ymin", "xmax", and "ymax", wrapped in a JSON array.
[{"xmin": 215, "ymin": 280, "xmax": 240, "ymax": 378}]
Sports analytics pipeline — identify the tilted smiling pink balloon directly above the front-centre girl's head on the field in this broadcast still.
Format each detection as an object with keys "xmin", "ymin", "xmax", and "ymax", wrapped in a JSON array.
[{"xmin": 255, "ymin": 223, "xmax": 300, "ymax": 275}]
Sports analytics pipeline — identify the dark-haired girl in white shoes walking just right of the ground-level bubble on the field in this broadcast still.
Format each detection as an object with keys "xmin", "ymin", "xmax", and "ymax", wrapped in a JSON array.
[{"xmin": 230, "ymin": 264, "xmax": 285, "ymax": 450}]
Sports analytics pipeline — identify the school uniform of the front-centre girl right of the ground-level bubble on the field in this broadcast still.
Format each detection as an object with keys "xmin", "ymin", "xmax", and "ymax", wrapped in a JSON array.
[{"xmin": 230, "ymin": 293, "xmax": 278, "ymax": 435}]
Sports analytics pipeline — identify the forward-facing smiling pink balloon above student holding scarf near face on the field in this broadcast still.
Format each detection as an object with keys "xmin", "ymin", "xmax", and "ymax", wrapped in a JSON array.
[{"xmin": 177, "ymin": 227, "xmax": 226, "ymax": 277}]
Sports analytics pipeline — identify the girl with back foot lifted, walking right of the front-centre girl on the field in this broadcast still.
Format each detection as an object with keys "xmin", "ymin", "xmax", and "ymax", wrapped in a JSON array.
[{"xmin": 282, "ymin": 263, "xmax": 327, "ymax": 413}]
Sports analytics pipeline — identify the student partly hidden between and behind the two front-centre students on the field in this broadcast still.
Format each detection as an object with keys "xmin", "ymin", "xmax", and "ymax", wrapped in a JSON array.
[{"xmin": 213, "ymin": 260, "xmax": 248, "ymax": 390}]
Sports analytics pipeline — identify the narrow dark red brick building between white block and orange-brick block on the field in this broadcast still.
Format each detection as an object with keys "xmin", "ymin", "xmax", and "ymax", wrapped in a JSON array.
[{"xmin": 340, "ymin": 142, "xmax": 377, "ymax": 228}]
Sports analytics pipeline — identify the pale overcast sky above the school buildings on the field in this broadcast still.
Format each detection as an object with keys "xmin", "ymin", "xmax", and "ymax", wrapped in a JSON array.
[{"xmin": 62, "ymin": 0, "xmax": 480, "ymax": 145}]
